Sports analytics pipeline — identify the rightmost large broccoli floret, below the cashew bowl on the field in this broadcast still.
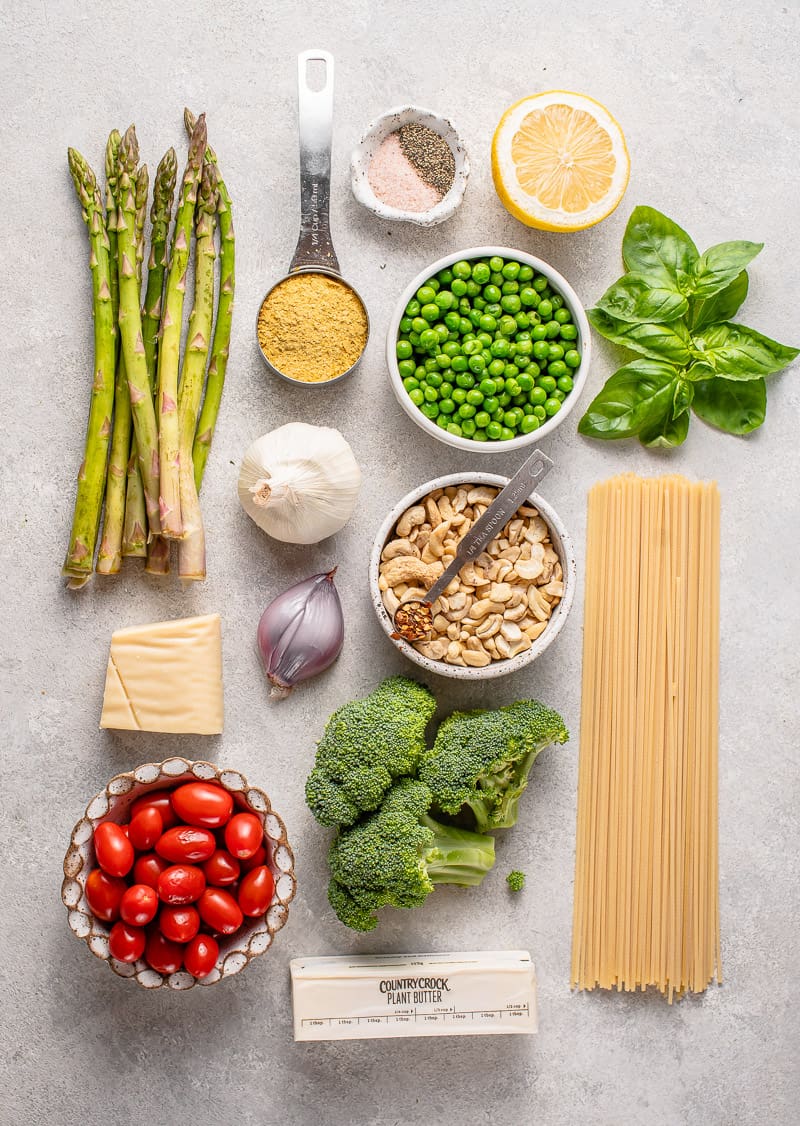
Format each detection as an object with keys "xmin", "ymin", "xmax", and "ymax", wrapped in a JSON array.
[{"xmin": 419, "ymin": 700, "xmax": 569, "ymax": 832}]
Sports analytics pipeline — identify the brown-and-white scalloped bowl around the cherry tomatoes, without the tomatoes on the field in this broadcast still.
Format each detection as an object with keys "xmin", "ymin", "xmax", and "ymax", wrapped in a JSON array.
[{"xmin": 61, "ymin": 758, "xmax": 296, "ymax": 990}]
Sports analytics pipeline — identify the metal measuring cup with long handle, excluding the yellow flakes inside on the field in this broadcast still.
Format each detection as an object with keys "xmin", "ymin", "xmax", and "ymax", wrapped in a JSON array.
[{"xmin": 256, "ymin": 51, "xmax": 370, "ymax": 387}]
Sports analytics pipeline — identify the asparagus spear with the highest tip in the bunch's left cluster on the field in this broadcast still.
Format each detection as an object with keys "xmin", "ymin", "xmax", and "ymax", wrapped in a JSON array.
[{"xmin": 117, "ymin": 125, "xmax": 161, "ymax": 533}]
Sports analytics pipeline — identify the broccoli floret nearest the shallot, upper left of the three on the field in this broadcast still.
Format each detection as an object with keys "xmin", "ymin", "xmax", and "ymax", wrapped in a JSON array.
[{"xmin": 305, "ymin": 677, "xmax": 436, "ymax": 825}]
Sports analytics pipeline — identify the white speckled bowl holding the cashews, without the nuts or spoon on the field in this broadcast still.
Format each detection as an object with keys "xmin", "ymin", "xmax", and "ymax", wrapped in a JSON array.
[{"xmin": 370, "ymin": 472, "xmax": 577, "ymax": 680}]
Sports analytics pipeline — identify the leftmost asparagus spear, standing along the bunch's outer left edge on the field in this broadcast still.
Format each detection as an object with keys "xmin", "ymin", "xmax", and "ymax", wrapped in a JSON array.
[{"xmin": 63, "ymin": 149, "xmax": 116, "ymax": 586}]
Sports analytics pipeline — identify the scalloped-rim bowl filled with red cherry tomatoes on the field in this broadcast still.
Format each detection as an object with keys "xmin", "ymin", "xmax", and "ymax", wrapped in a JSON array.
[{"xmin": 61, "ymin": 758, "xmax": 296, "ymax": 990}]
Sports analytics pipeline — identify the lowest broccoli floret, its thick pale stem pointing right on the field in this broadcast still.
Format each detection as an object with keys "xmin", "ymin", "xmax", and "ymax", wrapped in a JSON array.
[{"xmin": 328, "ymin": 778, "xmax": 495, "ymax": 930}]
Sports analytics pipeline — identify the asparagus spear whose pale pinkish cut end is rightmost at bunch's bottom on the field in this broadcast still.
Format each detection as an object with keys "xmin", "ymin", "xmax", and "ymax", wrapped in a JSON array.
[{"xmin": 178, "ymin": 164, "xmax": 217, "ymax": 579}]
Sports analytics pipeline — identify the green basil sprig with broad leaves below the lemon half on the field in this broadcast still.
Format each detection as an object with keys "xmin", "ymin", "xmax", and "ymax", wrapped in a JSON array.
[{"xmin": 578, "ymin": 207, "xmax": 799, "ymax": 447}]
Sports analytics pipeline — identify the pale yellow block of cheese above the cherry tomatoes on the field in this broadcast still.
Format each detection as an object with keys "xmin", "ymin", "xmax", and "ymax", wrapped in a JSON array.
[{"xmin": 100, "ymin": 614, "xmax": 223, "ymax": 735}]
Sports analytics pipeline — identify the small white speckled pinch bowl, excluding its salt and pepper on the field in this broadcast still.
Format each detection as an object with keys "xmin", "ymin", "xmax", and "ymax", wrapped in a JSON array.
[{"xmin": 350, "ymin": 106, "xmax": 470, "ymax": 226}]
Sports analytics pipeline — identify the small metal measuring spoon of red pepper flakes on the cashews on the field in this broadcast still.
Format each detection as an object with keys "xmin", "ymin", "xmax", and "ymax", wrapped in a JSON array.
[{"xmin": 392, "ymin": 449, "xmax": 553, "ymax": 641}]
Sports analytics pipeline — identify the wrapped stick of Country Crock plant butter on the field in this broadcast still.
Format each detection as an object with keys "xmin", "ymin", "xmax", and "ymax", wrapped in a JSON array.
[{"xmin": 290, "ymin": 950, "xmax": 537, "ymax": 1040}]
